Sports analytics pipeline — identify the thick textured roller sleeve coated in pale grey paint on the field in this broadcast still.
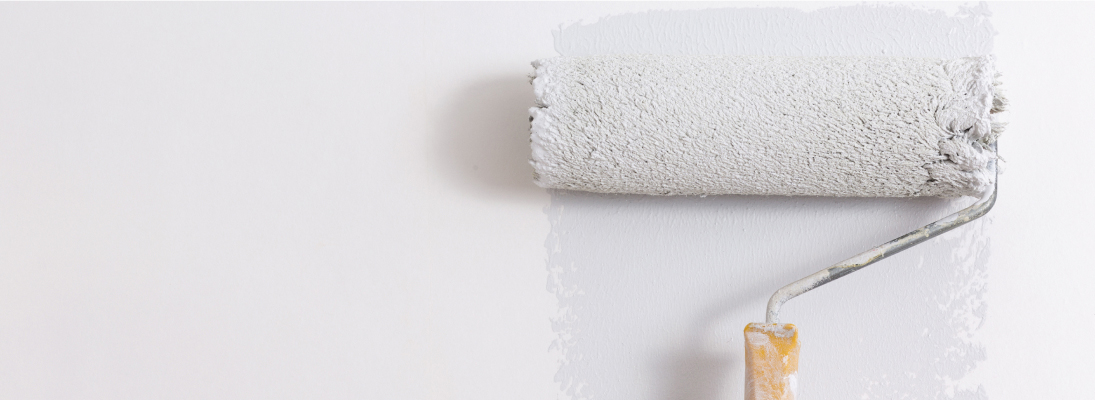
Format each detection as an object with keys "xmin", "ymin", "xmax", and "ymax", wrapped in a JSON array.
[{"xmin": 529, "ymin": 56, "xmax": 1004, "ymax": 197}]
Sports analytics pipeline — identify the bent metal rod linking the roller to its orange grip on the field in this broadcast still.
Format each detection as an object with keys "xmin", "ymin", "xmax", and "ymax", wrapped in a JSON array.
[{"xmin": 764, "ymin": 152, "xmax": 1000, "ymax": 323}]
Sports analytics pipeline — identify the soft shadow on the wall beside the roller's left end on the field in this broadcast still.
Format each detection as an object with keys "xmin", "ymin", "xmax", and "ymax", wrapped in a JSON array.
[{"xmin": 435, "ymin": 76, "xmax": 544, "ymax": 202}]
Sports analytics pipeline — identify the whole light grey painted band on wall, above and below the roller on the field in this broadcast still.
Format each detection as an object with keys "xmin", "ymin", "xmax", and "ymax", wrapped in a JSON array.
[{"xmin": 546, "ymin": 5, "xmax": 1006, "ymax": 400}]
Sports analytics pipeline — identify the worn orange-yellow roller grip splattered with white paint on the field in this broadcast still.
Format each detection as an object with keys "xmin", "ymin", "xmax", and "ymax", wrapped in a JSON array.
[{"xmin": 746, "ymin": 323, "xmax": 798, "ymax": 400}]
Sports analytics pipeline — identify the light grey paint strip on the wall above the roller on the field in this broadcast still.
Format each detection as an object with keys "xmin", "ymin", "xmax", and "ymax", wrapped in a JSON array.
[{"xmin": 555, "ymin": 5, "xmax": 995, "ymax": 58}]
